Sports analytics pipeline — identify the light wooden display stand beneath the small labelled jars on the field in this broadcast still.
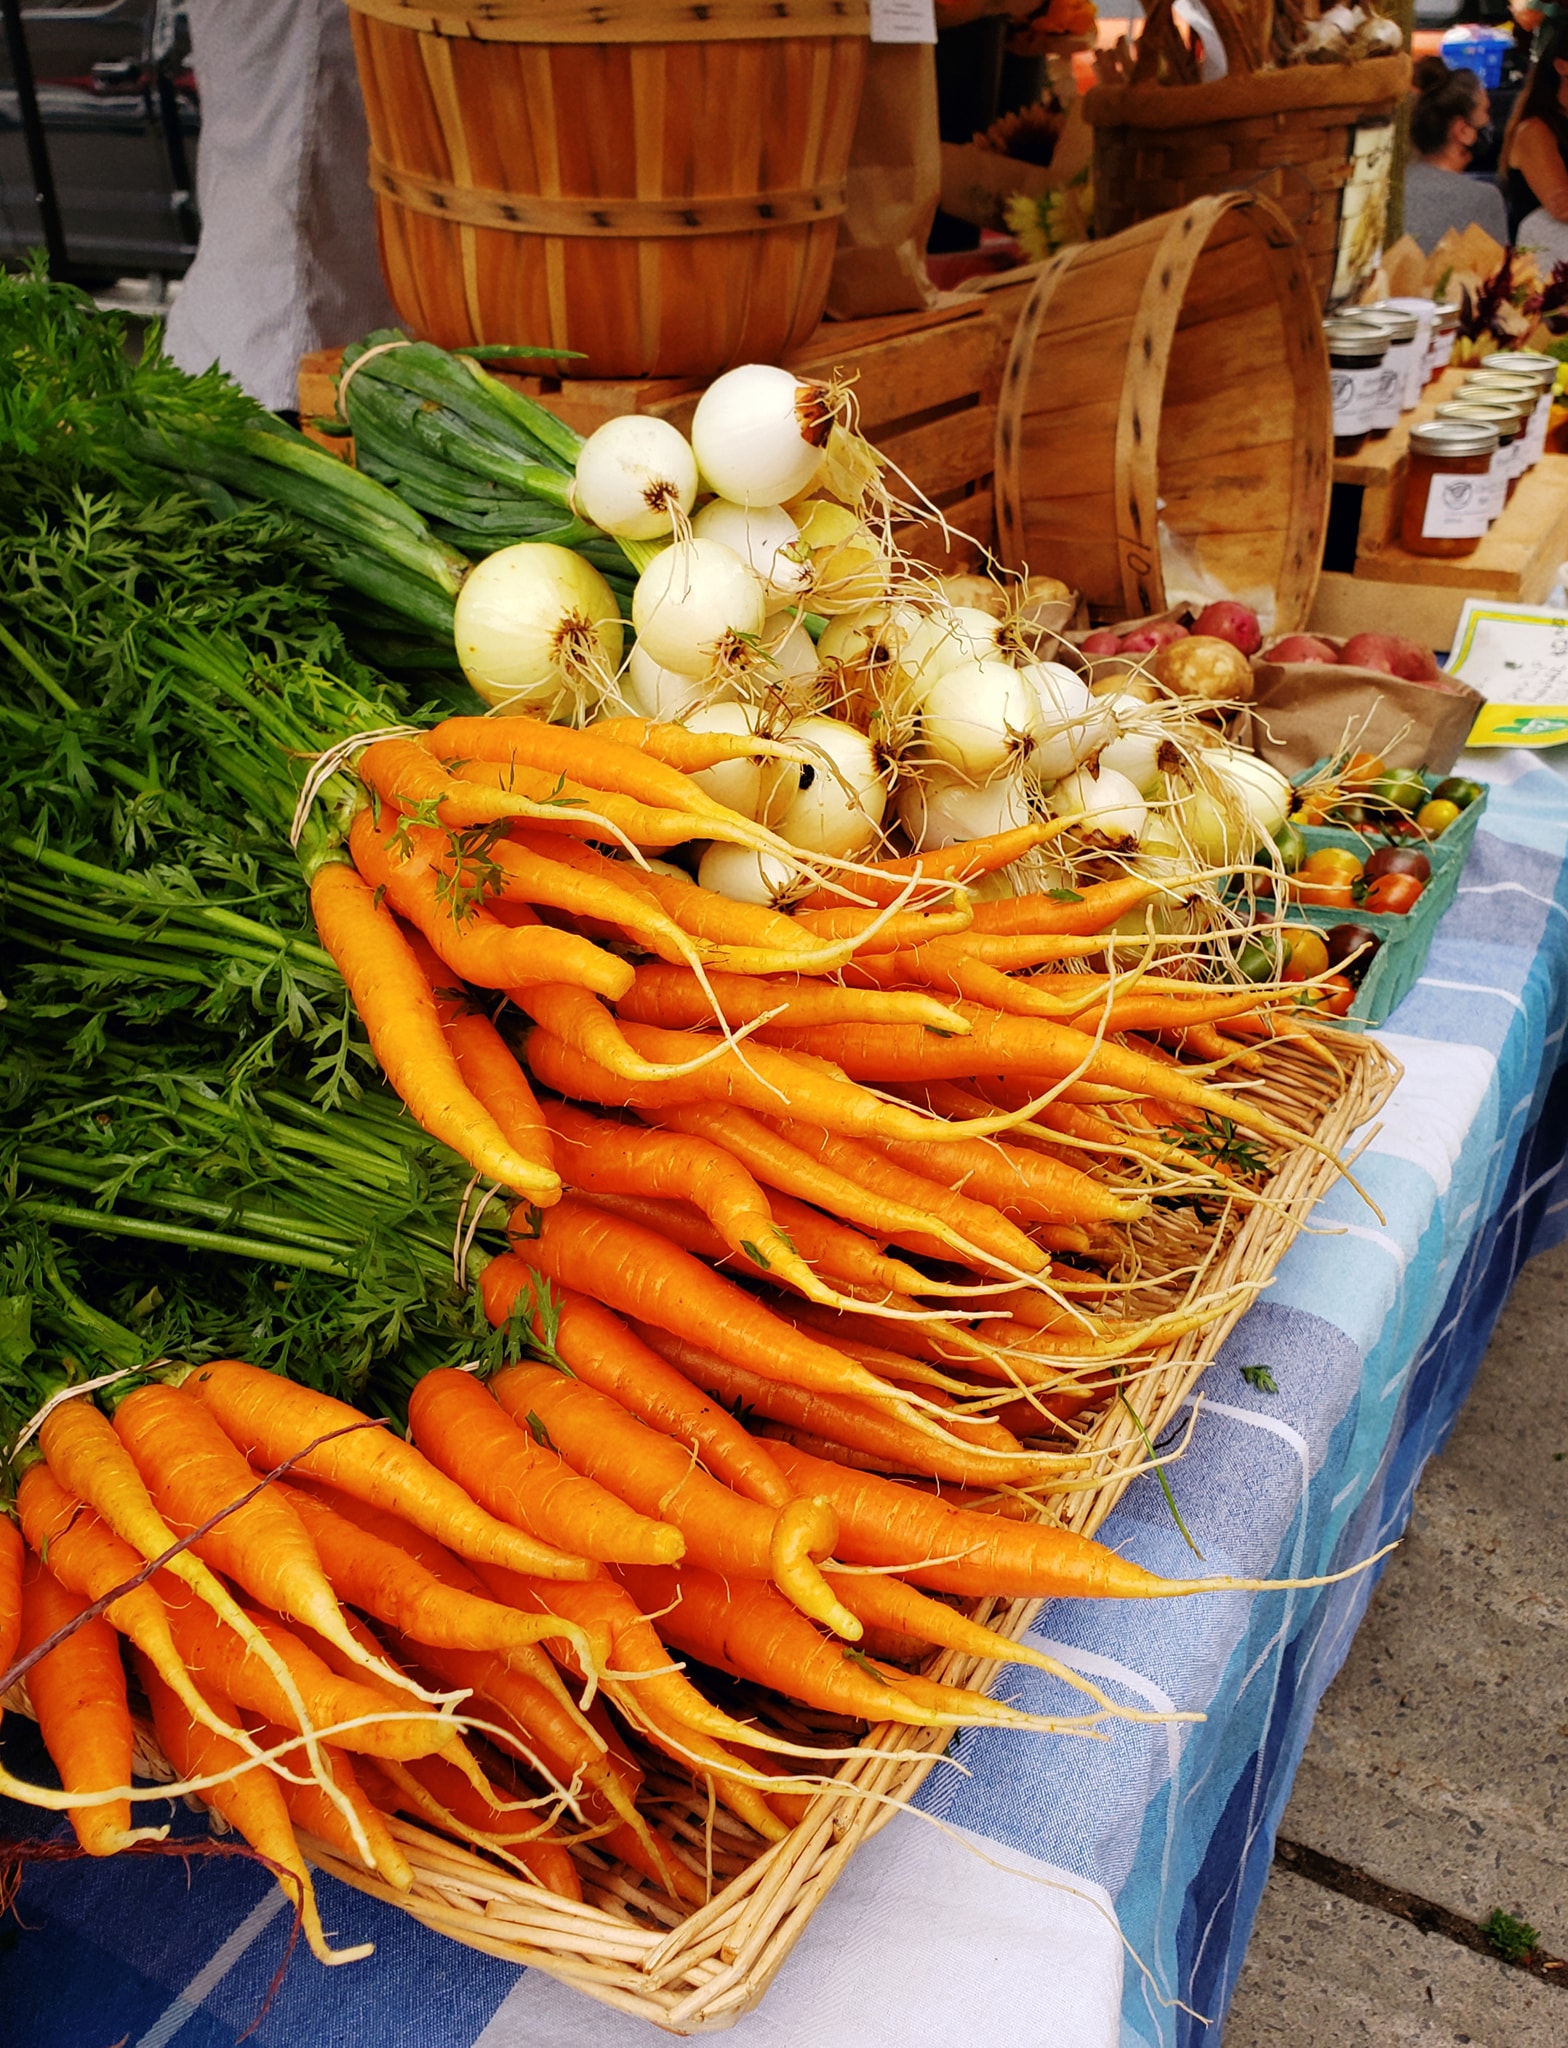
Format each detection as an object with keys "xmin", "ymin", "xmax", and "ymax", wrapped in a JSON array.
[{"xmin": 1308, "ymin": 371, "xmax": 1568, "ymax": 647}]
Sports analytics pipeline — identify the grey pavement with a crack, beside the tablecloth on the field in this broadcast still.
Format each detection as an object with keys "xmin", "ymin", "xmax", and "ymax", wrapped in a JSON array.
[{"xmin": 1224, "ymin": 1245, "xmax": 1568, "ymax": 2048}]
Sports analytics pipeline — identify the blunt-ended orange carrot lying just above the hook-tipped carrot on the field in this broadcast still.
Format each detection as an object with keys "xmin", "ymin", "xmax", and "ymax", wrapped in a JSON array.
[{"xmin": 479, "ymin": 1251, "xmax": 794, "ymax": 1507}]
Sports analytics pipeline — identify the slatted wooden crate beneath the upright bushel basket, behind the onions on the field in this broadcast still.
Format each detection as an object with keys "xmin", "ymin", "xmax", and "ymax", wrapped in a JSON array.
[{"xmin": 299, "ymin": 292, "xmax": 1034, "ymax": 569}]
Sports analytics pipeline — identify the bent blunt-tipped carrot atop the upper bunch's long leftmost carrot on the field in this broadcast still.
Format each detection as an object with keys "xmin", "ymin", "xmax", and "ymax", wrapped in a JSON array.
[{"xmin": 348, "ymin": 805, "xmax": 633, "ymax": 995}]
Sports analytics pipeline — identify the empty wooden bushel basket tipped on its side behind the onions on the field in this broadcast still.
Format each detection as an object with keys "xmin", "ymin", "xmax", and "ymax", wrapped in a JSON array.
[{"xmin": 997, "ymin": 193, "xmax": 1333, "ymax": 633}]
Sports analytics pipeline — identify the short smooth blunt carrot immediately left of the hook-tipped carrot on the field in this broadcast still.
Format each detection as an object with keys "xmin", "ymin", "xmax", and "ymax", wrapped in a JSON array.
[{"xmin": 399, "ymin": 1366, "xmax": 684, "ymax": 1564}]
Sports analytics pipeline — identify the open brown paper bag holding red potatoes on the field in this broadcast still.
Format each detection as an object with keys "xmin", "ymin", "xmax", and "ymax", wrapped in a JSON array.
[{"xmin": 1253, "ymin": 662, "xmax": 1484, "ymax": 780}]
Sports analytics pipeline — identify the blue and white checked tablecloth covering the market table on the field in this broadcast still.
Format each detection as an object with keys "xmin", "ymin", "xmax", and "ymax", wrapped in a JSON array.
[{"xmin": 0, "ymin": 754, "xmax": 1568, "ymax": 2048}]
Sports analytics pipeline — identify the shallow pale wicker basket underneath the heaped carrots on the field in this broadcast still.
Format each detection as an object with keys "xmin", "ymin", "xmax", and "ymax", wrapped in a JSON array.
[{"xmin": 6, "ymin": 1032, "xmax": 1398, "ymax": 2034}]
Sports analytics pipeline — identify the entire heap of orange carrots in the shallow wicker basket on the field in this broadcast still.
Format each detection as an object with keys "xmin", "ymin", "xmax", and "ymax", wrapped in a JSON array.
[{"xmin": 0, "ymin": 717, "xmax": 1359, "ymax": 1962}]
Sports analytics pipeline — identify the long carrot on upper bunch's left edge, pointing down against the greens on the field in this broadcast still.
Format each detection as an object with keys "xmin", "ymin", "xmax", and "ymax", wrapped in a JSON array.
[{"xmin": 311, "ymin": 862, "xmax": 561, "ymax": 1202}]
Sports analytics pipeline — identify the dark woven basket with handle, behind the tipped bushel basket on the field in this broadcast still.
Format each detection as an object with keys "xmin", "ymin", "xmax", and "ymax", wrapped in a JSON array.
[{"xmin": 1083, "ymin": 0, "xmax": 1410, "ymax": 307}]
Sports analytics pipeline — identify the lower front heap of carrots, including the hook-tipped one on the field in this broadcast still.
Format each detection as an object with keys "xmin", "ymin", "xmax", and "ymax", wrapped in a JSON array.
[{"xmin": 0, "ymin": 1343, "xmax": 1342, "ymax": 1962}]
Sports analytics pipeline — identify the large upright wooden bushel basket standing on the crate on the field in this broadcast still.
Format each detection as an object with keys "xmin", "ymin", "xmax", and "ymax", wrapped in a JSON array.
[{"xmin": 350, "ymin": 0, "xmax": 870, "ymax": 377}]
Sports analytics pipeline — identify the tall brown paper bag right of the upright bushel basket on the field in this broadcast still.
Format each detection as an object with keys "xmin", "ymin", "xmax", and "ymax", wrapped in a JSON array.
[{"xmin": 827, "ymin": 43, "xmax": 942, "ymax": 319}]
